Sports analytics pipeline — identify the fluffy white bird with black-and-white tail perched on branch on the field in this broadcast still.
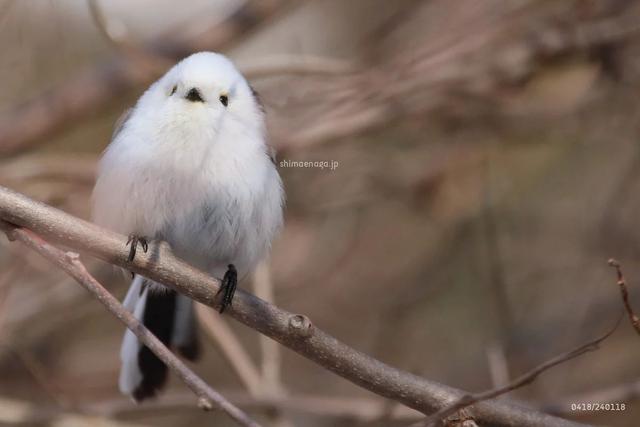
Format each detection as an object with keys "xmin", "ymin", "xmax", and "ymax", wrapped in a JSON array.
[{"xmin": 92, "ymin": 52, "xmax": 284, "ymax": 402}]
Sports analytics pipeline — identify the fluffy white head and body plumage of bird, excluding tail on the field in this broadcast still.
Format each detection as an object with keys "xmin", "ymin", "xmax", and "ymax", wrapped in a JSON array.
[{"xmin": 94, "ymin": 52, "xmax": 283, "ymax": 278}]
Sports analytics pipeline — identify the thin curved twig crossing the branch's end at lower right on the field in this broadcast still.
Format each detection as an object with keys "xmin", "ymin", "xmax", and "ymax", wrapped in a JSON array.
[{"xmin": 412, "ymin": 317, "xmax": 622, "ymax": 427}]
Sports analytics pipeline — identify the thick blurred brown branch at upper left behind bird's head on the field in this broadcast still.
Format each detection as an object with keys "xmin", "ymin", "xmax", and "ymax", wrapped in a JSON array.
[{"xmin": 0, "ymin": 0, "xmax": 286, "ymax": 156}]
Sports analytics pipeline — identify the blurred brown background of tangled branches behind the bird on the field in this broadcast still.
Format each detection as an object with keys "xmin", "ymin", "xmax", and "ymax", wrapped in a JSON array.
[{"xmin": 0, "ymin": 0, "xmax": 640, "ymax": 426}]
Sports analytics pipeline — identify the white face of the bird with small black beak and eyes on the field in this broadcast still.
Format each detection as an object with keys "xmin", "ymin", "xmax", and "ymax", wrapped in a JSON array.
[{"xmin": 140, "ymin": 52, "xmax": 263, "ymax": 141}]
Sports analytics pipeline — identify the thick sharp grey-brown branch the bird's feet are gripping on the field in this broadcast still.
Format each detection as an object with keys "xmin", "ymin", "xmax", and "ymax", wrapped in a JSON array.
[{"xmin": 0, "ymin": 187, "xmax": 592, "ymax": 427}]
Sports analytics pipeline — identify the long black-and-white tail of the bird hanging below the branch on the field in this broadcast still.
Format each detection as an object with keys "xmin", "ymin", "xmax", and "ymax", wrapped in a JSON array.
[{"xmin": 119, "ymin": 275, "xmax": 200, "ymax": 401}]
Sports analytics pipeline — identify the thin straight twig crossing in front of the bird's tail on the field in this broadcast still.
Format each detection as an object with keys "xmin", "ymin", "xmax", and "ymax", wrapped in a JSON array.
[{"xmin": 0, "ymin": 221, "xmax": 260, "ymax": 427}]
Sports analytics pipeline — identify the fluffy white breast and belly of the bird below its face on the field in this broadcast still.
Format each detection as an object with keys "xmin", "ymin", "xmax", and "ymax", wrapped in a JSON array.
[{"xmin": 94, "ymin": 102, "xmax": 282, "ymax": 277}]
